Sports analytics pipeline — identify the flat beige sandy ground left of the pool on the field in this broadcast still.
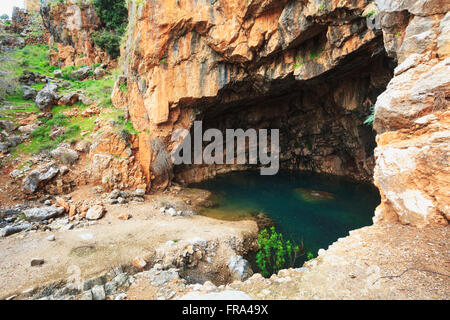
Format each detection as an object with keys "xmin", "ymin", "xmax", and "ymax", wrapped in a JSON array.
[{"xmin": 0, "ymin": 199, "xmax": 256, "ymax": 298}]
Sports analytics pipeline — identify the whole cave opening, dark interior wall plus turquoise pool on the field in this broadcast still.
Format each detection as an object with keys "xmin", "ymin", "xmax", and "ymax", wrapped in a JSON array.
[{"xmin": 169, "ymin": 37, "xmax": 395, "ymax": 272}]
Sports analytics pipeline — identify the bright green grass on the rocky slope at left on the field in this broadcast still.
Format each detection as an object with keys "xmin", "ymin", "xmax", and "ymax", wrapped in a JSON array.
[{"xmin": 0, "ymin": 44, "xmax": 130, "ymax": 159}]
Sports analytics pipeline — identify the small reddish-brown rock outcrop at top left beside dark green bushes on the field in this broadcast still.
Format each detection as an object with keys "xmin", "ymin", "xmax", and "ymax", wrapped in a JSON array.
[{"xmin": 40, "ymin": 0, "xmax": 113, "ymax": 67}]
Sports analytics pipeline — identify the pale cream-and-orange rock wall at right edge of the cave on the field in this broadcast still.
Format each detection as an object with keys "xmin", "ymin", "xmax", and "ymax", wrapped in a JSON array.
[{"xmin": 374, "ymin": 0, "xmax": 450, "ymax": 226}]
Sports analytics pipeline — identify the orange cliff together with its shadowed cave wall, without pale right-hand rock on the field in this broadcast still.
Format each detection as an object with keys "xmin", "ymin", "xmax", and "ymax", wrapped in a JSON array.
[{"xmin": 117, "ymin": 0, "xmax": 393, "ymax": 186}]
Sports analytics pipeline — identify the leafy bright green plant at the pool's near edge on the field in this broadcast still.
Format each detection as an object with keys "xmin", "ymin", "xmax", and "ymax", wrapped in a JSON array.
[{"xmin": 256, "ymin": 227, "xmax": 304, "ymax": 277}]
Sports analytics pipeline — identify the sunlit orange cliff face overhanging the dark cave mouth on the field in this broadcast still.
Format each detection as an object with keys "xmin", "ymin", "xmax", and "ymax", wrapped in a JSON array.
[{"xmin": 113, "ymin": 0, "xmax": 385, "ymax": 188}]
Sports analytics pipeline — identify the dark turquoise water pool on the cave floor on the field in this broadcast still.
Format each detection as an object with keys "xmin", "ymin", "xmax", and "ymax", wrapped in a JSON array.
[{"xmin": 191, "ymin": 171, "xmax": 380, "ymax": 262}]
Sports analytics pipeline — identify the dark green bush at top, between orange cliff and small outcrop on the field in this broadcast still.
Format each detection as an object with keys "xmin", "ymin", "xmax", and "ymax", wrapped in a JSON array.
[{"xmin": 92, "ymin": 0, "xmax": 128, "ymax": 58}]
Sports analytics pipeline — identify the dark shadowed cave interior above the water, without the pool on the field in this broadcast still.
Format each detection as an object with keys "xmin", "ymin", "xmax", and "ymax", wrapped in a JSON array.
[{"xmin": 174, "ymin": 54, "xmax": 393, "ymax": 184}]
